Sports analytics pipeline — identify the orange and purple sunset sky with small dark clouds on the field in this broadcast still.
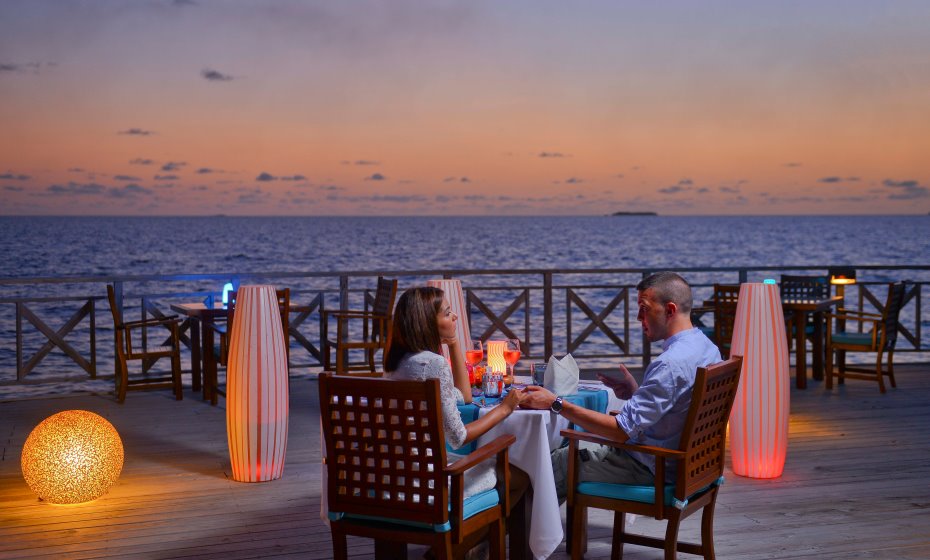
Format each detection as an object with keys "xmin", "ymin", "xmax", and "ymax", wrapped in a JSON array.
[{"xmin": 0, "ymin": 0, "xmax": 930, "ymax": 215}]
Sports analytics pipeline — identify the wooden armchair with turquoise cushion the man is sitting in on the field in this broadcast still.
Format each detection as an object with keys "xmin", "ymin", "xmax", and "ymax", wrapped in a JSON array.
[{"xmin": 562, "ymin": 356, "xmax": 743, "ymax": 560}]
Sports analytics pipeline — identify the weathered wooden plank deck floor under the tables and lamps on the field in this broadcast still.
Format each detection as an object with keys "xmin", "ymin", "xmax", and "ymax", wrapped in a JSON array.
[{"xmin": 0, "ymin": 366, "xmax": 930, "ymax": 560}]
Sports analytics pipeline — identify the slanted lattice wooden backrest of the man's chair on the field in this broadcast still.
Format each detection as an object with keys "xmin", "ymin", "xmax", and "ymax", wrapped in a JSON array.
[{"xmin": 675, "ymin": 356, "xmax": 743, "ymax": 500}]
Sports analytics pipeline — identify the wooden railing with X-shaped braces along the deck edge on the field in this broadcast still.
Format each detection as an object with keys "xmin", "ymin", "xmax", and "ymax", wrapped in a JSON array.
[{"xmin": 0, "ymin": 265, "xmax": 930, "ymax": 390}]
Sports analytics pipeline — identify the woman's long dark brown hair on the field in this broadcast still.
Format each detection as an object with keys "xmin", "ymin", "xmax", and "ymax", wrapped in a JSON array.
[{"xmin": 384, "ymin": 286, "xmax": 443, "ymax": 371}]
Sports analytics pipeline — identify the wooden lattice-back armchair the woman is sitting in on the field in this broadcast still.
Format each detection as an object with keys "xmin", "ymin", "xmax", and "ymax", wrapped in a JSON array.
[{"xmin": 319, "ymin": 373, "xmax": 516, "ymax": 560}]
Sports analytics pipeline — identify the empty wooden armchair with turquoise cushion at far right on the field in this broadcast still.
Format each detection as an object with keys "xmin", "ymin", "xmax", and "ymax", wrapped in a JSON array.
[{"xmin": 826, "ymin": 282, "xmax": 907, "ymax": 393}]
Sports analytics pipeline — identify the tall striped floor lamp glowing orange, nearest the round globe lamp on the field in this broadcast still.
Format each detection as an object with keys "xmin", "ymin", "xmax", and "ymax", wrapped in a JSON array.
[{"xmin": 226, "ymin": 286, "xmax": 288, "ymax": 482}]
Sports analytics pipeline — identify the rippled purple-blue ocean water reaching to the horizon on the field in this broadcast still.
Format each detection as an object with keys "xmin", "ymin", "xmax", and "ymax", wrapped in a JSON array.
[{"xmin": 0, "ymin": 216, "xmax": 930, "ymax": 399}]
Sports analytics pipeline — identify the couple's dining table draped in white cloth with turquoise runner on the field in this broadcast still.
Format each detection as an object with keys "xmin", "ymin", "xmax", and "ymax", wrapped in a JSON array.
[{"xmin": 457, "ymin": 376, "xmax": 626, "ymax": 558}]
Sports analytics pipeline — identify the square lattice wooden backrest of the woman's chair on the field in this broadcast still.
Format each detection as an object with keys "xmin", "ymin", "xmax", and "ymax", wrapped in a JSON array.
[{"xmin": 319, "ymin": 373, "xmax": 449, "ymax": 524}]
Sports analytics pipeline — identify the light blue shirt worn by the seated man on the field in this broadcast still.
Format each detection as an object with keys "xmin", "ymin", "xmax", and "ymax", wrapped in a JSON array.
[{"xmin": 617, "ymin": 328, "xmax": 721, "ymax": 483}]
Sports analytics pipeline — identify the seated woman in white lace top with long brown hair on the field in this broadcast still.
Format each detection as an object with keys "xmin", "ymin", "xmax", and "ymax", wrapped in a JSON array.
[{"xmin": 384, "ymin": 287, "xmax": 530, "ymax": 558}]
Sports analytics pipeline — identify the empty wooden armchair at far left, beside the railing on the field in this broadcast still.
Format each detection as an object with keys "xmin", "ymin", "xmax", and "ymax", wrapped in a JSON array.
[{"xmin": 107, "ymin": 284, "xmax": 184, "ymax": 402}]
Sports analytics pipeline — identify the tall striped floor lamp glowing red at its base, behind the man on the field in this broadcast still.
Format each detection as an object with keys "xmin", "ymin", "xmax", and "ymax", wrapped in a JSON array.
[{"xmin": 730, "ymin": 283, "xmax": 790, "ymax": 478}]
